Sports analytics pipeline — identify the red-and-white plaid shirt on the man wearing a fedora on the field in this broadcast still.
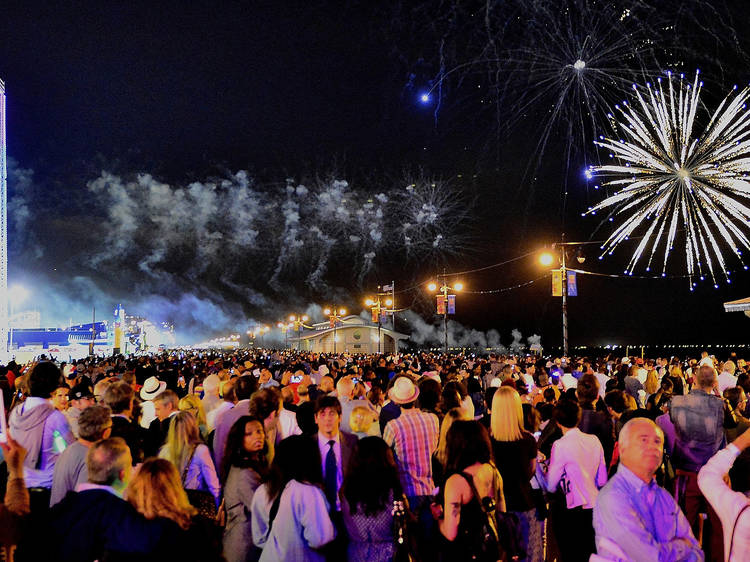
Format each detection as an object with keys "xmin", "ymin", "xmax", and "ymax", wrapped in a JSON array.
[{"xmin": 383, "ymin": 408, "xmax": 440, "ymax": 496}]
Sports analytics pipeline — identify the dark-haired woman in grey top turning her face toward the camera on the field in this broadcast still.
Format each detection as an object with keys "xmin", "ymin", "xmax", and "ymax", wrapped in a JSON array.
[{"xmin": 221, "ymin": 416, "xmax": 268, "ymax": 562}]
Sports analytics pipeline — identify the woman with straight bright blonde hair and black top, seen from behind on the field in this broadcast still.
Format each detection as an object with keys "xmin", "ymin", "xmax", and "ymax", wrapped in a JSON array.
[{"xmin": 490, "ymin": 386, "xmax": 544, "ymax": 562}]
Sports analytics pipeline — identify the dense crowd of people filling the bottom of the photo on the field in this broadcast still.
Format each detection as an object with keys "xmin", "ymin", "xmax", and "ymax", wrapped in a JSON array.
[{"xmin": 0, "ymin": 350, "xmax": 750, "ymax": 562}]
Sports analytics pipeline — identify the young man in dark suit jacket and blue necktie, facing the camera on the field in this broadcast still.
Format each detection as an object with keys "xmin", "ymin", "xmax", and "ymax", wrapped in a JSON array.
[{"xmin": 315, "ymin": 396, "xmax": 357, "ymax": 560}]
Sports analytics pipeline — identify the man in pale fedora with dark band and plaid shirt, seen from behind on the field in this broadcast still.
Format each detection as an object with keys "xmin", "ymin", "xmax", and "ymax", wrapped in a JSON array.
[{"xmin": 383, "ymin": 376, "xmax": 440, "ymax": 559}]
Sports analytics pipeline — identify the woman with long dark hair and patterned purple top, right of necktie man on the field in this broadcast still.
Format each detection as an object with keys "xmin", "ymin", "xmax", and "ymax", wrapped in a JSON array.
[{"xmin": 340, "ymin": 437, "xmax": 403, "ymax": 562}]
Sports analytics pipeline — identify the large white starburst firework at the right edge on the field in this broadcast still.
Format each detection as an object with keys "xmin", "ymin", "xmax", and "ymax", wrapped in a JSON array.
[{"xmin": 584, "ymin": 73, "xmax": 750, "ymax": 290}]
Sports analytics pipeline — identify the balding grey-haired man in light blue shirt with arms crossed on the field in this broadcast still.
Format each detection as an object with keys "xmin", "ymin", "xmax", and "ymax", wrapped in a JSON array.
[{"xmin": 594, "ymin": 418, "xmax": 704, "ymax": 561}]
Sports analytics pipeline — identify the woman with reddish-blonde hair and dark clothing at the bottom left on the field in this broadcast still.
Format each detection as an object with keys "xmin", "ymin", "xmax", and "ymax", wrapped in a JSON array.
[{"xmin": 126, "ymin": 458, "xmax": 220, "ymax": 560}]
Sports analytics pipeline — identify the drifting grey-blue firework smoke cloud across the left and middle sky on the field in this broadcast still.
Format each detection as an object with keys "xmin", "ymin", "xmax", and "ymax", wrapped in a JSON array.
[{"xmin": 8, "ymin": 160, "xmax": 476, "ymax": 343}]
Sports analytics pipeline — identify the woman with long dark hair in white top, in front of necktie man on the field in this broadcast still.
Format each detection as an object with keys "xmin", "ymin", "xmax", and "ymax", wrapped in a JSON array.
[{"xmin": 251, "ymin": 435, "xmax": 336, "ymax": 562}]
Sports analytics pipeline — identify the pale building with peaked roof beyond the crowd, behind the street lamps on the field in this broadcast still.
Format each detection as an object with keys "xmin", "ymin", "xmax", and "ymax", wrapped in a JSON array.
[{"xmin": 289, "ymin": 315, "xmax": 409, "ymax": 353}]
